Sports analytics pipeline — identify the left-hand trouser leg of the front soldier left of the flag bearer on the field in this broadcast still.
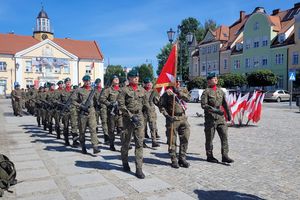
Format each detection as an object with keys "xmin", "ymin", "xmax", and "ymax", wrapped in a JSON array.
[{"xmin": 121, "ymin": 118, "xmax": 133, "ymax": 165}]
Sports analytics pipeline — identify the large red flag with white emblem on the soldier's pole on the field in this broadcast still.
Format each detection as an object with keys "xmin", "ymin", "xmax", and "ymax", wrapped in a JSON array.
[{"xmin": 154, "ymin": 43, "xmax": 177, "ymax": 93}]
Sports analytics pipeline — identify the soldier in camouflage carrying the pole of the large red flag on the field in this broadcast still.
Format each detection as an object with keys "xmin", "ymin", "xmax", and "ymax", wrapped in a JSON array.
[{"xmin": 159, "ymin": 79, "xmax": 190, "ymax": 168}]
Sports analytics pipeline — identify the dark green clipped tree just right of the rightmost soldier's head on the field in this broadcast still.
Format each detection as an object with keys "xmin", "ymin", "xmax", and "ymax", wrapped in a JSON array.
[{"xmin": 220, "ymin": 74, "xmax": 247, "ymax": 88}]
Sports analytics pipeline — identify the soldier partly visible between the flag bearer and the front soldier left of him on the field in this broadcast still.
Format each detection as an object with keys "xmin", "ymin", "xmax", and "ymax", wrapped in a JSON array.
[{"xmin": 143, "ymin": 77, "xmax": 159, "ymax": 147}]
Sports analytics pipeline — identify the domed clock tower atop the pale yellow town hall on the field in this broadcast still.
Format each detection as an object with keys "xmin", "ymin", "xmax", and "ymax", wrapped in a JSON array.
[{"xmin": 33, "ymin": 7, "xmax": 53, "ymax": 41}]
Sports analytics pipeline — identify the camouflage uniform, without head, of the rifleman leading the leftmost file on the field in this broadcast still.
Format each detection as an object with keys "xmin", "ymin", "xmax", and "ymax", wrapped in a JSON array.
[{"xmin": 77, "ymin": 87, "xmax": 99, "ymax": 153}]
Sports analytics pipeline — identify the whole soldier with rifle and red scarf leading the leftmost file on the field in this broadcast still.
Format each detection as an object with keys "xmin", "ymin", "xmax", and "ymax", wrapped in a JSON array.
[{"xmin": 77, "ymin": 75, "xmax": 100, "ymax": 154}]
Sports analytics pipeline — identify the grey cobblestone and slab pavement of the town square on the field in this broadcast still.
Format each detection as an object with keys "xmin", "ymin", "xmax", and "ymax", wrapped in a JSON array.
[{"xmin": 0, "ymin": 100, "xmax": 300, "ymax": 200}]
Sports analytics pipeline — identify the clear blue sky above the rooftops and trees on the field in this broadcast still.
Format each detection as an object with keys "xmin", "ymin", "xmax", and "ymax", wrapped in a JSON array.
[{"xmin": 0, "ymin": 0, "xmax": 300, "ymax": 72}]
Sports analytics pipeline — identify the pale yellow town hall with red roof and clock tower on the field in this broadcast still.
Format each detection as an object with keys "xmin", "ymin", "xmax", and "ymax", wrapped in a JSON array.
[{"xmin": 0, "ymin": 9, "xmax": 104, "ymax": 95}]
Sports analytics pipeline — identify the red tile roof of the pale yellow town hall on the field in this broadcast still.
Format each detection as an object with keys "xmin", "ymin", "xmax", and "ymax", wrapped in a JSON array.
[{"xmin": 0, "ymin": 33, "xmax": 103, "ymax": 60}]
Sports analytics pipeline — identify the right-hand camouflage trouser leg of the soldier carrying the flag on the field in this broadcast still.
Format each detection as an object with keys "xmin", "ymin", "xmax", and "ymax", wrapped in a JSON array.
[{"xmin": 178, "ymin": 119, "xmax": 190, "ymax": 160}]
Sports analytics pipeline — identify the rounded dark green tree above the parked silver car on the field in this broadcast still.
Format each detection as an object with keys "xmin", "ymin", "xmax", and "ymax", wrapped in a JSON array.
[{"xmin": 247, "ymin": 69, "xmax": 278, "ymax": 87}]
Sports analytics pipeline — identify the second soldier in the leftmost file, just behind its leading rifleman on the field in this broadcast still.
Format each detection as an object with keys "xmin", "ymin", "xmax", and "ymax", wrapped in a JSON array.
[{"xmin": 60, "ymin": 78, "xmax": 79, "ymax": 147}]
